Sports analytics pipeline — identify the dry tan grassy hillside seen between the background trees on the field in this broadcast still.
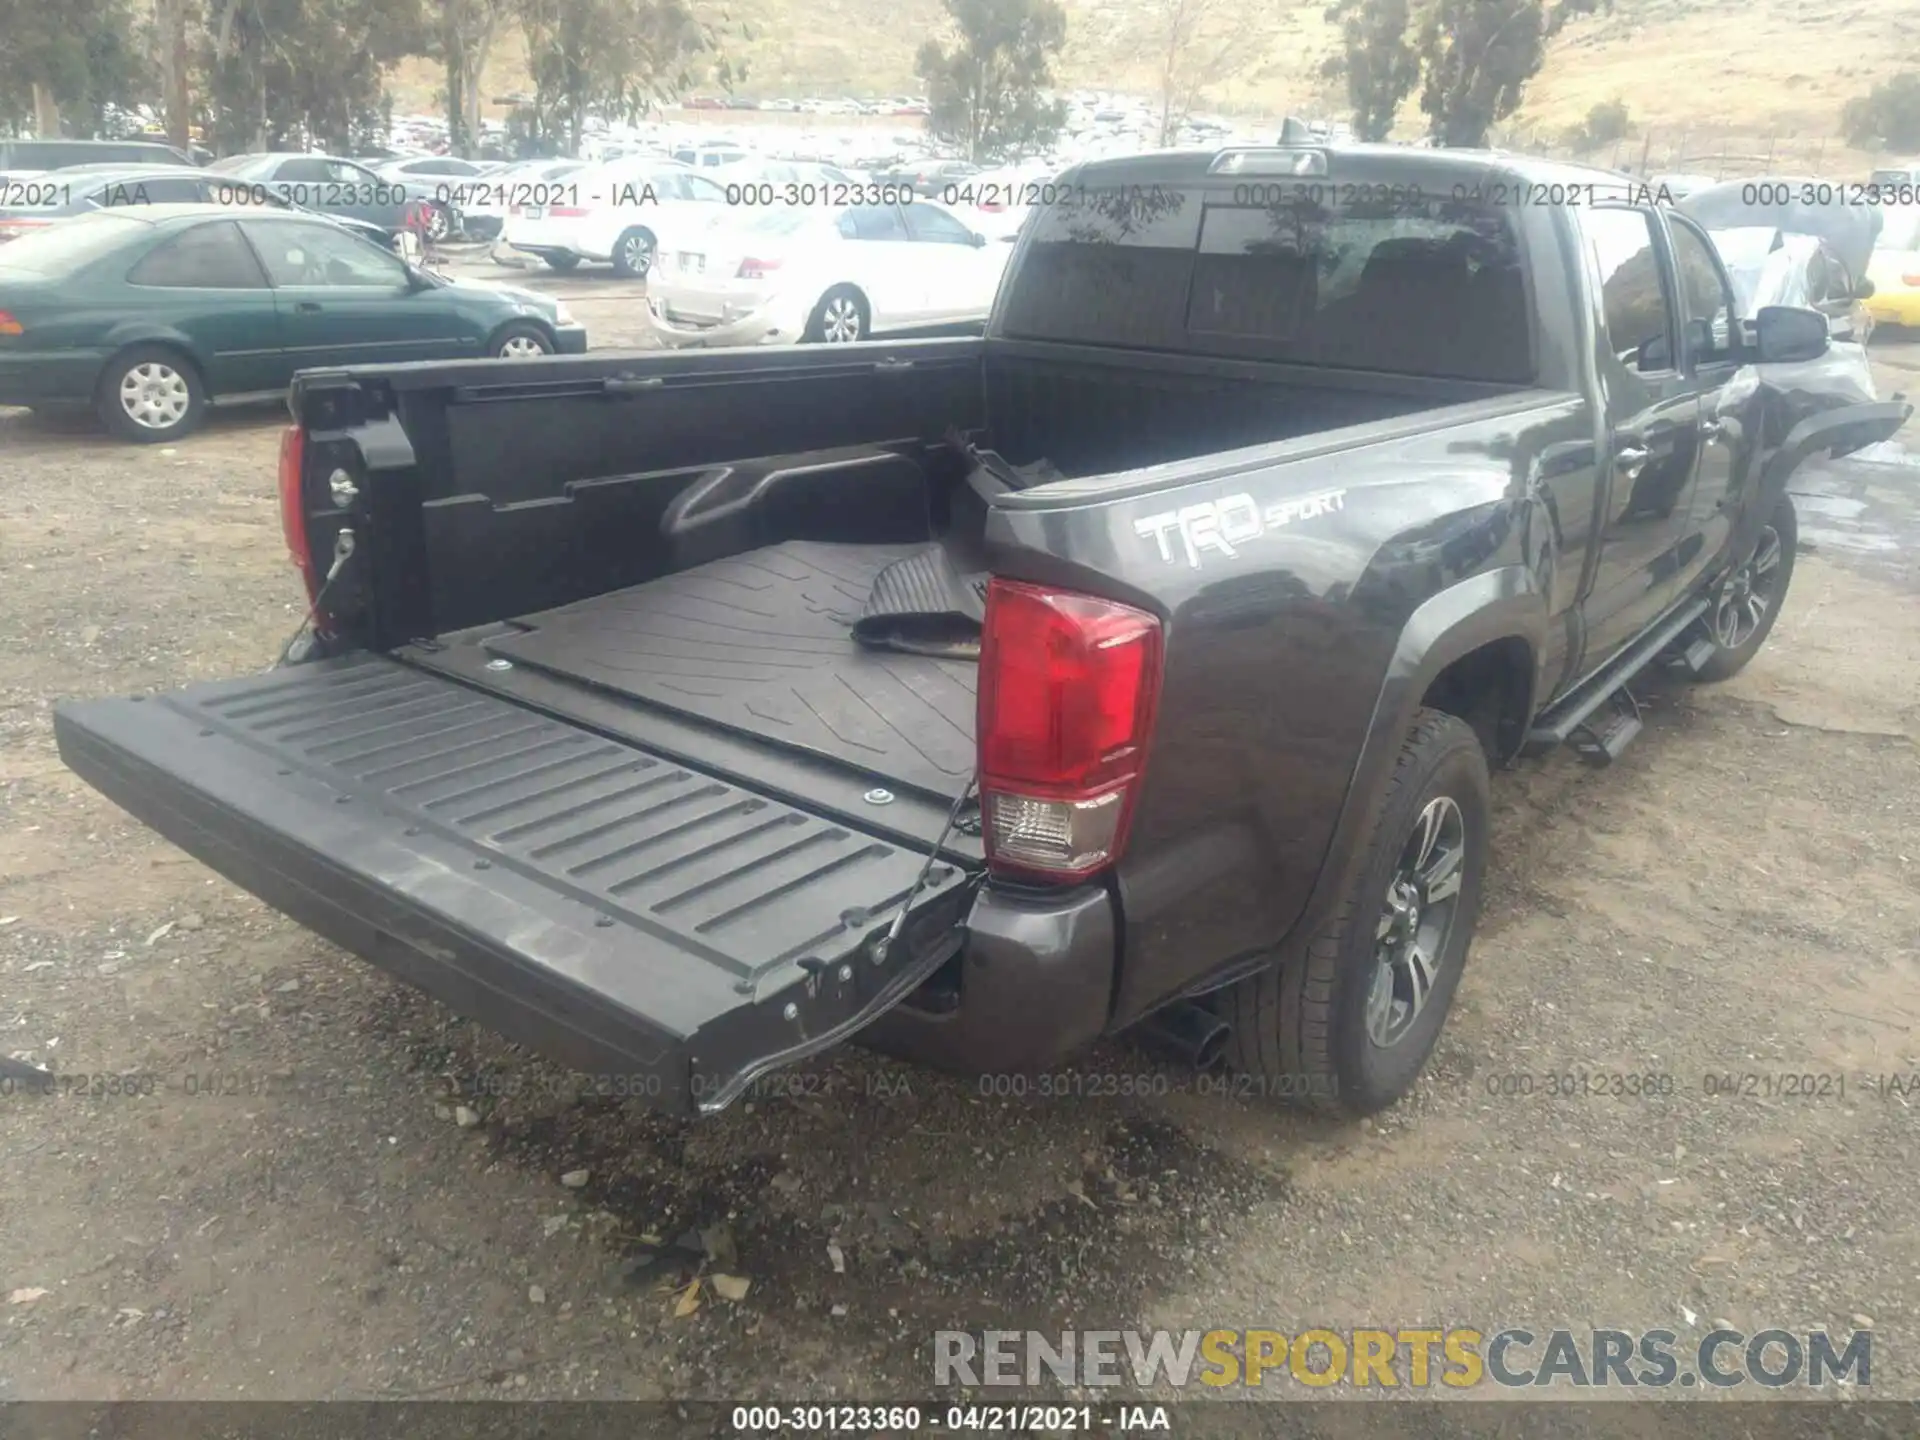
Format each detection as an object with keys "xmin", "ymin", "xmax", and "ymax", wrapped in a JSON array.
[{"xmin": 396, "ymin": 0, "xmax": 1920, "ymax": 152}]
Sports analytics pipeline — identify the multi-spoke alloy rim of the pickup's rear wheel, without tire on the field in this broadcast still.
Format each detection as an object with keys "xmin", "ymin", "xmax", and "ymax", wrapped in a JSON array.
[{"xmin": 1367, "ymin": 795, "xmax": 1467, "ymax": 1050}]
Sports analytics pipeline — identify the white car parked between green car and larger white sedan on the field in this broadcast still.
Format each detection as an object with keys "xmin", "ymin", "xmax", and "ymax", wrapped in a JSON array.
[{"xmin": 505, "ymin": 156, "xmax": 726, "ymax": 275}]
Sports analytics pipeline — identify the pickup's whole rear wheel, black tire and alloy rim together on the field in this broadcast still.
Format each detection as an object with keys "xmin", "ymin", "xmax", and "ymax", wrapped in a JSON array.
[{"xmin": 1219, "ymin": 710, "xmax": 1492, "ymax": 1116}]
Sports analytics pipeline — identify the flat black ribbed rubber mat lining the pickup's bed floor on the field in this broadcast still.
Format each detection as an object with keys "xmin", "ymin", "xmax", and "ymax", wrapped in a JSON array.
[{"xmin": 486, "ymin": 541, "xmax": 977, "ymax": 799}]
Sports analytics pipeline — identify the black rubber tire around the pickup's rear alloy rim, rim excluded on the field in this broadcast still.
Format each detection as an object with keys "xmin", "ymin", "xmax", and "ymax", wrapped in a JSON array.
[{"xmin": 1217, "ymin": 710, "xmax": 1492, "ymax": 1116}]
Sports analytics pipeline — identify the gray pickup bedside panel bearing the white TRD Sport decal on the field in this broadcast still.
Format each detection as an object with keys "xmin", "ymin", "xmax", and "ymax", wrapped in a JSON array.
[{"xmin": 989, "ymin": 392, "xmax": 1592, "ymax": 1025}]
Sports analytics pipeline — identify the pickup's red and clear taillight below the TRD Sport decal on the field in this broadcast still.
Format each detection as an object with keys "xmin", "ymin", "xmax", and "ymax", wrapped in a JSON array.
[{"xmin": 977, "ymin": 580, "xmax": 1162, "ymax": 879}]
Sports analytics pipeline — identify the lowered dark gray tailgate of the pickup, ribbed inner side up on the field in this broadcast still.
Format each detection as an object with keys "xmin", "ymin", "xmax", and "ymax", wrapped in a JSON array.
[{"xmin": 54, "ymin": 655, "xmax": 973, "ymax": 1112}]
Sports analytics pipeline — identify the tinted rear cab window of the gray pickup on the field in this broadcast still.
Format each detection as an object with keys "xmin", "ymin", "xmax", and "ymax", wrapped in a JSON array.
[{"xmin": 1002, "ymin": 175, "xmax": 1534, "ymax": 384}]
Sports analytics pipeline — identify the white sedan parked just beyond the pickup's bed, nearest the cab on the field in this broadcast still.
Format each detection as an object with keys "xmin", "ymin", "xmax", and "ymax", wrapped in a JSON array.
[{"xmin": 647, "ymin": 200, "xmax": 1012, "ymax": 346}]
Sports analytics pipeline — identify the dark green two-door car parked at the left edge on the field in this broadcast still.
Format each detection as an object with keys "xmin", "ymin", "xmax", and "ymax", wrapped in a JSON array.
[{"xmin": 0, "ymin": 205, "xmax": 588, "ymax": 444}]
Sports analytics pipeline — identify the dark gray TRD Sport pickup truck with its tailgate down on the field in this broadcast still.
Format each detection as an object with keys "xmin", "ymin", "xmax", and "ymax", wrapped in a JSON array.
[{"xmin": 56, "ymin": 146, "xmax": 1908, "ymax": 1114}]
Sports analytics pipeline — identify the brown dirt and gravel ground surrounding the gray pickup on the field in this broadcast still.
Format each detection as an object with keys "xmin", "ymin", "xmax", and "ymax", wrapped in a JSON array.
[{"xmin": 0, "ymin": 288, "xmax": 1920, "ymax": 1400}]
